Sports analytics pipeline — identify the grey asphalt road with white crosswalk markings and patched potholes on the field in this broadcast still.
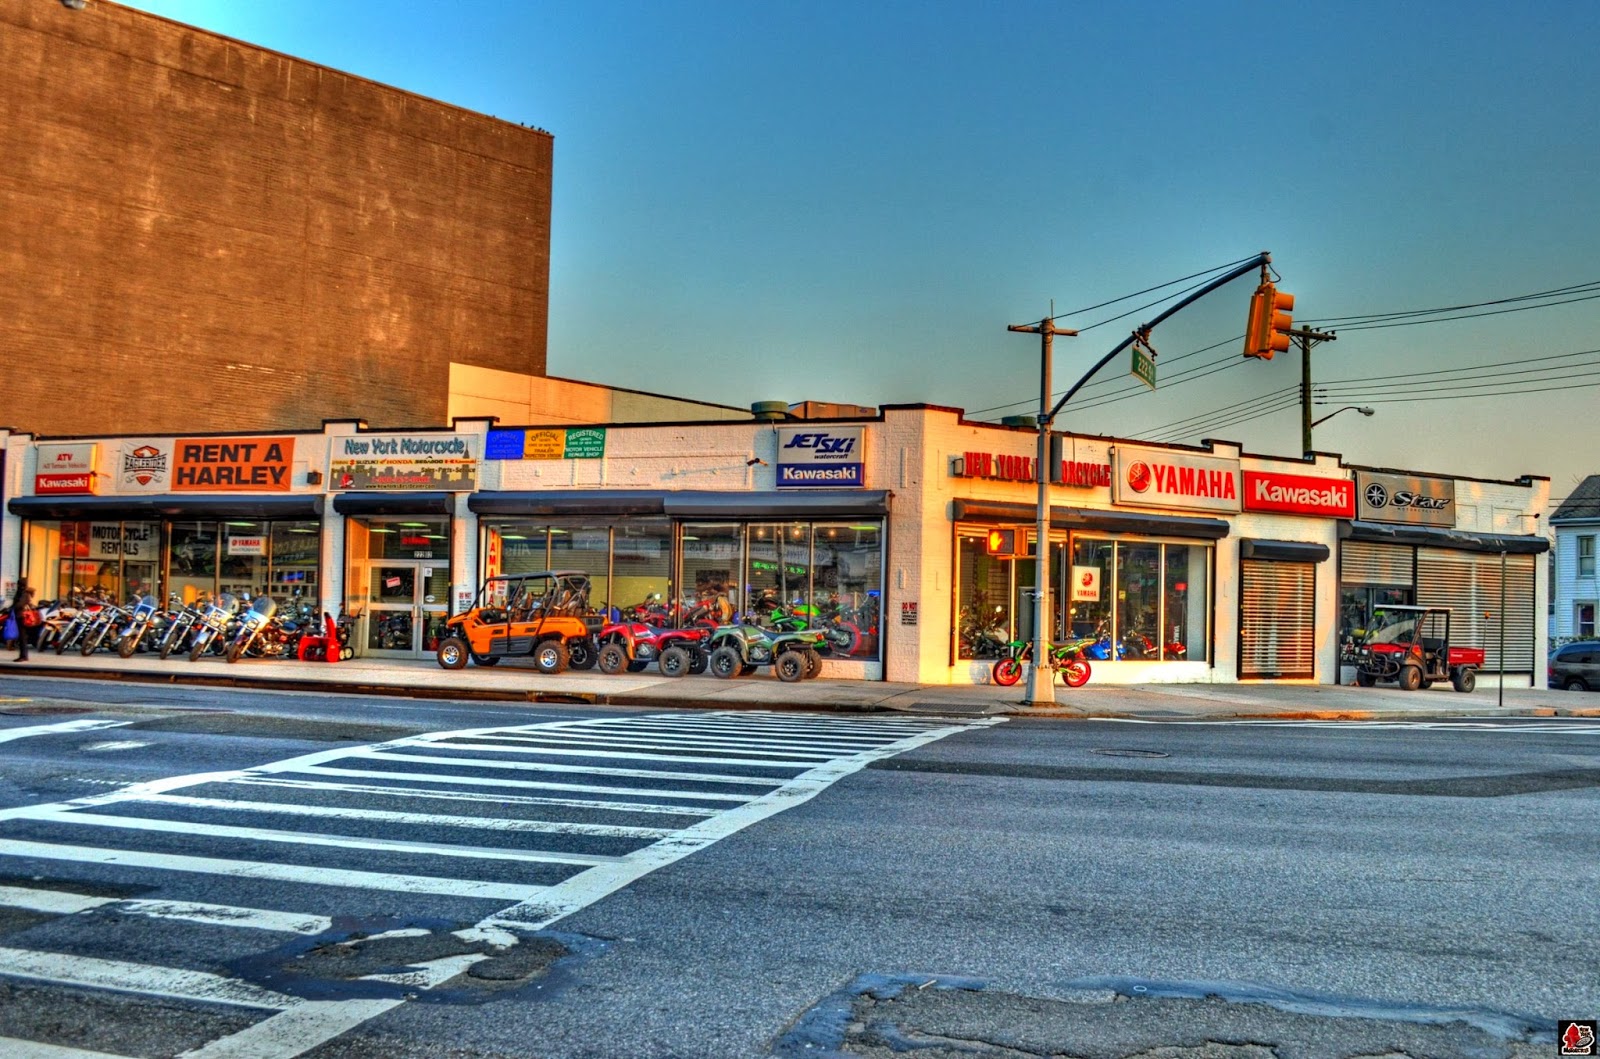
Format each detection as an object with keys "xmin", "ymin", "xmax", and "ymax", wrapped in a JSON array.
[{"xmin": 0, "ymin": 680, "xmax": 1600, "ymax": 1059}]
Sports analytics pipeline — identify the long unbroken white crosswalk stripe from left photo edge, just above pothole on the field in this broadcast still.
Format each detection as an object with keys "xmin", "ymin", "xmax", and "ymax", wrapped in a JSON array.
[{"xmin": 0, "ymin": 840, "xmax": 544, "ymax": 901}]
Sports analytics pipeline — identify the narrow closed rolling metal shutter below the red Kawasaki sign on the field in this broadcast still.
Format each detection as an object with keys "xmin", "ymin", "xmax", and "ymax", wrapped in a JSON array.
[{"xmin": 1238, "ymin": 558, "xmax": 1317, "ymax": 678}]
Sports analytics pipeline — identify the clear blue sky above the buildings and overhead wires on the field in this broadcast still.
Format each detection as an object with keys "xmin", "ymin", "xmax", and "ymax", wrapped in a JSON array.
[{"xmin": 121, "ymin": 0, "xmax": 1600, "ymax": 496}]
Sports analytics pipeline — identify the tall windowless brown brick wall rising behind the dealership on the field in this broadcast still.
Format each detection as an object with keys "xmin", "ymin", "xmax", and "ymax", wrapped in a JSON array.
[{"xmin": 0, "ymin": 0, "xmax": 552, "ymax": 435}]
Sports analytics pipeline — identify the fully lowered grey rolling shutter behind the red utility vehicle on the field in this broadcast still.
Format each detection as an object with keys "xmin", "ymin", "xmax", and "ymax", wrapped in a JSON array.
[{"xmin": 1416, "ymin": 547, "xmax": 1534, "ymax": 673}]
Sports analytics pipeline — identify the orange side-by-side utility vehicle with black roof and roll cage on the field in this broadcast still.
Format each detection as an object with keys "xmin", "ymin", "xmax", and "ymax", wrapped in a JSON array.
[{"xmin": 438, "ymin": 569, "xmax": 603, "ymax": 673}]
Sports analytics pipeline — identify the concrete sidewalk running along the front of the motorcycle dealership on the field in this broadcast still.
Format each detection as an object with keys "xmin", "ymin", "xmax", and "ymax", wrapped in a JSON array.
[{"xmin": 0, "ymin": 653, "xmax": 1600, "ymax": 721}]
